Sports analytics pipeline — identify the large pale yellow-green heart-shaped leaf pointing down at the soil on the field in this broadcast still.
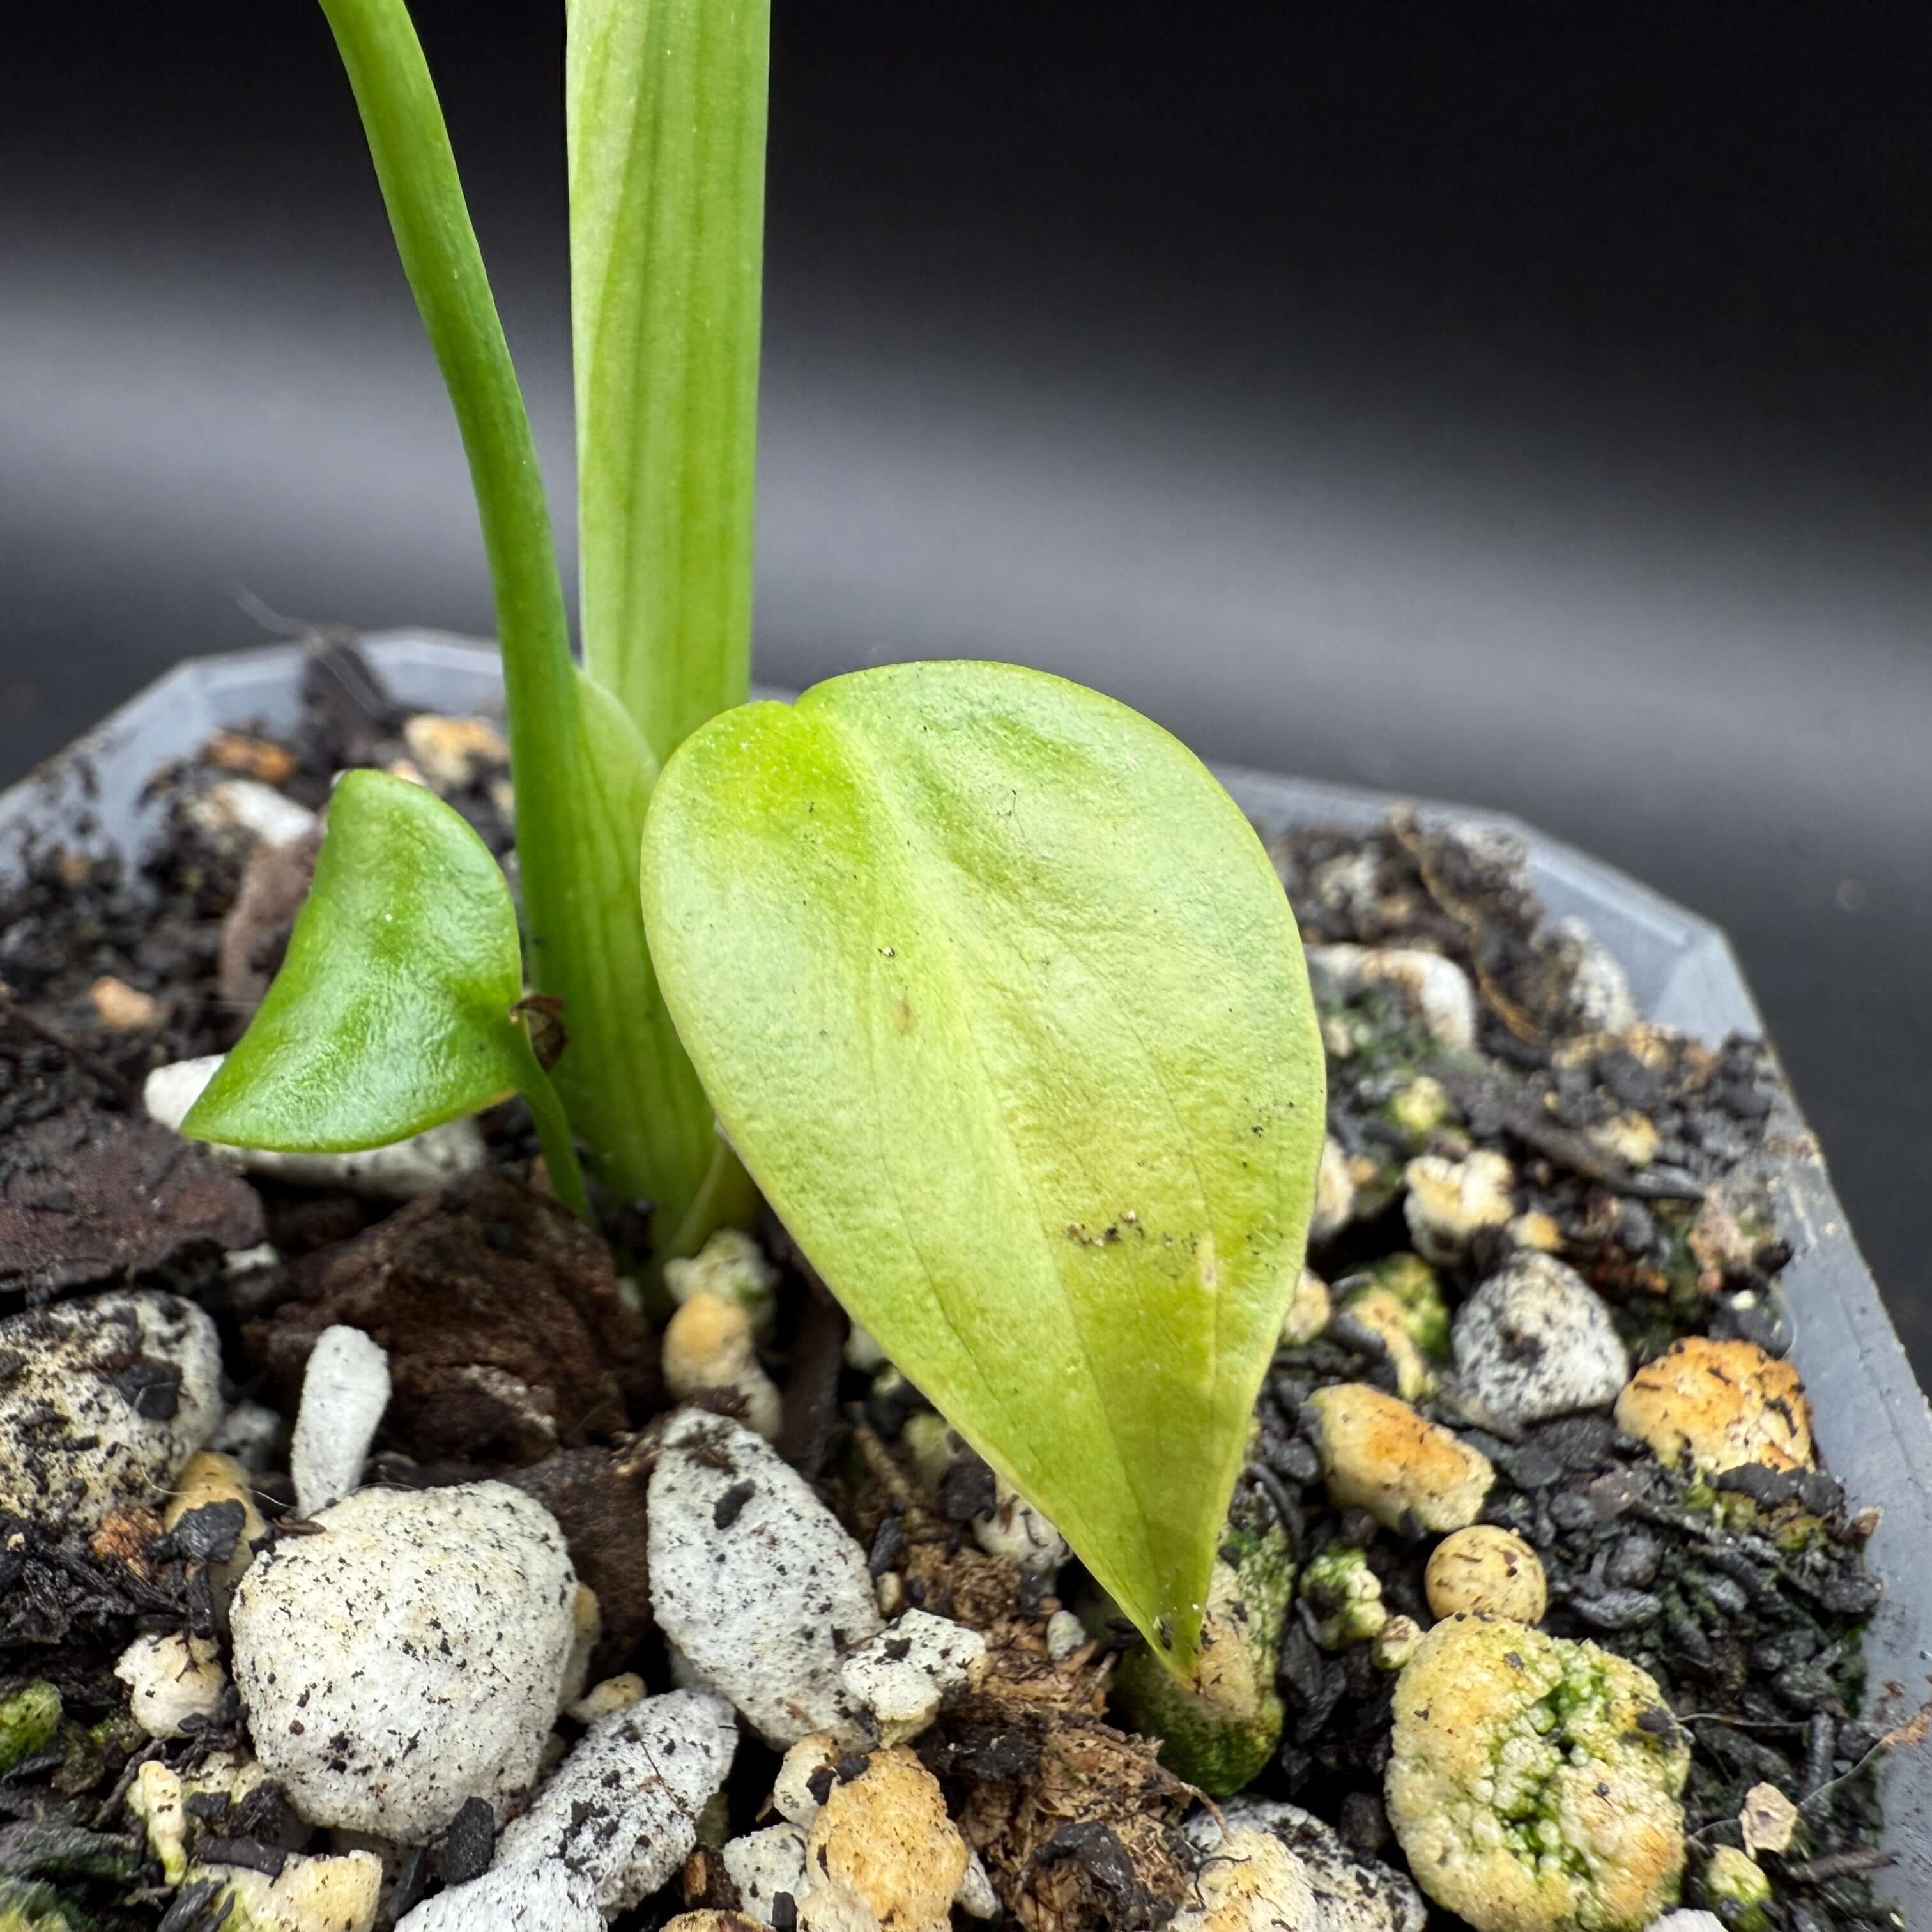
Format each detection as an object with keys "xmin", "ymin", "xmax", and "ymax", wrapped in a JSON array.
[{"xmin": 643, "ymin": 663, "xmax": 1323, "ymax": 1671}]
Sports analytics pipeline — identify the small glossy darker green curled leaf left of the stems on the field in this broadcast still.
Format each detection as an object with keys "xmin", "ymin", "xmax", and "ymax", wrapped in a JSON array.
[{"xmin": 181, "ymin": 771, "xmax": 541, "ymax": 1153}]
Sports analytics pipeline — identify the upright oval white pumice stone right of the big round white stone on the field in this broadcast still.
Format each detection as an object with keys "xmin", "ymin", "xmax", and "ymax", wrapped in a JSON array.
[{"xmin": 649, "ymin": 1408, "xmax": 879, "ymax": 1751}]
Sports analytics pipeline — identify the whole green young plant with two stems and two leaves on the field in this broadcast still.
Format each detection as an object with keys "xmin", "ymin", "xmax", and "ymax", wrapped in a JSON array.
[{"xmin": 185, "ymin": 0, "xmax": 1323, "ymax": 1675}]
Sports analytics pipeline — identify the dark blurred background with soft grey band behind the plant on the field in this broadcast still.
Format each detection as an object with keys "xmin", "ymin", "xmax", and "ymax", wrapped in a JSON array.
[{"xmin": 0, "ymin": 0, "xmax": 1932, "ymax": 1372}]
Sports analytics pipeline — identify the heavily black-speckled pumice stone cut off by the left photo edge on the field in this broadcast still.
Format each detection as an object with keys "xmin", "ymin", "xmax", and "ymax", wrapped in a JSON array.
[{"xmin": 0, "ymin": 1291, "xmax": 222, "ymax": 1532}]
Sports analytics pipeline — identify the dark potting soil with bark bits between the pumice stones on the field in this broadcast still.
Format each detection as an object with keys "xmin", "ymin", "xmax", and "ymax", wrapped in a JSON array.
[{"xmin": 0, "ymin": 640, "xmax": 1922, "ymax": 1932}]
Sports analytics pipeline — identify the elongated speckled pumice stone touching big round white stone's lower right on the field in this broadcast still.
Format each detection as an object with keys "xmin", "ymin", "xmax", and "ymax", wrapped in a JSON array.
[{"xmin": 493, "ymin": 1690, "xmax": 738, "ymax": 1915}]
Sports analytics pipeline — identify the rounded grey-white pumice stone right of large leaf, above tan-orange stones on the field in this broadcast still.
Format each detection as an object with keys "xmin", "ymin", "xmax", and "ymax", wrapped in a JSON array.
[{"xmin": 1449, "ymin": 1250, "xmax": 1630, "ymax": 1430}]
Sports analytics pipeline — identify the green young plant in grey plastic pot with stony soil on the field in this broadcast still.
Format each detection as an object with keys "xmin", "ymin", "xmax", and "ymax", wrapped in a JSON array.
[{"xmin": 0, "ymin": 0, "xmax": 1928, "ymax": 1932}]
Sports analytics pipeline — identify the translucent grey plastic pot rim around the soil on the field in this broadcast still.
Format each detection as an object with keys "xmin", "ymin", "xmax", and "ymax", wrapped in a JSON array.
[{"xmin": 0, "ymin": 632, "xmax": 1932, "ymax": 1919}]
